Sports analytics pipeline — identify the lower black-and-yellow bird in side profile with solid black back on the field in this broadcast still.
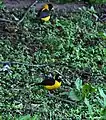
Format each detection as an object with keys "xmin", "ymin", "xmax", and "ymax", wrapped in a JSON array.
[{"xmin": 32, "ymin": 73, "xmax": 62, "ymax": 91}]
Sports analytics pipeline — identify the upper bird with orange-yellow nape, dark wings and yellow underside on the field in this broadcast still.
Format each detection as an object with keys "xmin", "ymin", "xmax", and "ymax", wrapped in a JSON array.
[{"xmin": 36, "ymin": 3, "xmax": 53, "ymax": 22}]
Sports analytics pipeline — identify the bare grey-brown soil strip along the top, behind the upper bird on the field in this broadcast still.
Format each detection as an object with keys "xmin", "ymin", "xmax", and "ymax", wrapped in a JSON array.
[{"xmin": 4, "ymin": 0, "xmax": 86, "ymax": 12}]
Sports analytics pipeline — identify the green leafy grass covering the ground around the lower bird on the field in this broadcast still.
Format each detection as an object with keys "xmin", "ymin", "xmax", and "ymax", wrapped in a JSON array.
[{"xmin": 0, "ymin": 4, "xmax": 106, "ymax": 120}]
